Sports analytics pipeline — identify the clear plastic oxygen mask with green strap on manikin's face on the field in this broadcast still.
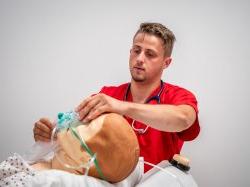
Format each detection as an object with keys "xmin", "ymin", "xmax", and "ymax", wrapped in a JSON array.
[{"xmin": 51, "ymin": 111, "xmax": 104, "ymax": 178}]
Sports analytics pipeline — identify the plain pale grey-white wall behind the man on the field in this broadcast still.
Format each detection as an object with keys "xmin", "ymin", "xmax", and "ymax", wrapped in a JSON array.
[{"xmin": 0, "ymin": 0, "xmax": 250, "ymax": 187}]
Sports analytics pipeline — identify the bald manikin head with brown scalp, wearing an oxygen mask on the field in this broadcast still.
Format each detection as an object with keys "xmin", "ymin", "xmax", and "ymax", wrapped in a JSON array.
[{"xmin": 33, "ymin": 112, "xmax": 139, "ymax": 183}]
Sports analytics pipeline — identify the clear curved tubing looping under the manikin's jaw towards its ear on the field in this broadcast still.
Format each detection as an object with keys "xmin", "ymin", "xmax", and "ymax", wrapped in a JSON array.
[{"xmin": 51, "ymin": 126, "xmax": 96, "ymax": 176}]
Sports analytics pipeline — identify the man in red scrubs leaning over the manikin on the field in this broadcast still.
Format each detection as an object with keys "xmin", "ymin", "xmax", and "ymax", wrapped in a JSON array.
[{"xmin": 34, "ymin": 23, "xmax": 200, "ymax": 172}]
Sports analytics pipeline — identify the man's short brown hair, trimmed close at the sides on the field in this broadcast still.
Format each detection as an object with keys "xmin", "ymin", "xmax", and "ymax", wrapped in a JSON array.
[{"xmin": 134, "ymin": 22, "xmax": 176, "ymax": 56}]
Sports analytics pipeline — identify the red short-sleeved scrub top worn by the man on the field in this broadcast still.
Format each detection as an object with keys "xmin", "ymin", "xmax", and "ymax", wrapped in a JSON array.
[{"xmin": 100, "ymin": 83, "xmax": 200, "ymax": 172}]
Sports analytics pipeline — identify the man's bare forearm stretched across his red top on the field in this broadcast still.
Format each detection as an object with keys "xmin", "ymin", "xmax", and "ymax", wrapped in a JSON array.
[{"xmin": 119, "ymin": 102, "xmax": 196, "ymax": 132}]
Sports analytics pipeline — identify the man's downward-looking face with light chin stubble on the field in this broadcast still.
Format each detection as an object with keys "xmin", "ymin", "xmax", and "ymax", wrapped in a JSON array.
[{"xmin": 129, "ymin": 33, "xmax": 171, "ymax": 82}]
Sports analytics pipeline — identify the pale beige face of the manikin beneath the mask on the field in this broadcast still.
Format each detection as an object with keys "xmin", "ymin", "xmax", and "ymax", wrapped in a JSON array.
[{"xmin": 52, "ymin": 115, "xmax": 105, "ymax": 174}]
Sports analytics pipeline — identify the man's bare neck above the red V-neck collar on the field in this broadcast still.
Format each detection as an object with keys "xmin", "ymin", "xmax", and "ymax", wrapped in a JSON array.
[{"xmin": 130, "ymin": 80, "xmax": 161, "ymax": 103}]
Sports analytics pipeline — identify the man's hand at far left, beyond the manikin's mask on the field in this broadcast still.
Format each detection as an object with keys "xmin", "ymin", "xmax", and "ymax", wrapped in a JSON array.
[{"xmin": 33, "ymin": 118, "xmax": 55, "ymax": 142}]
